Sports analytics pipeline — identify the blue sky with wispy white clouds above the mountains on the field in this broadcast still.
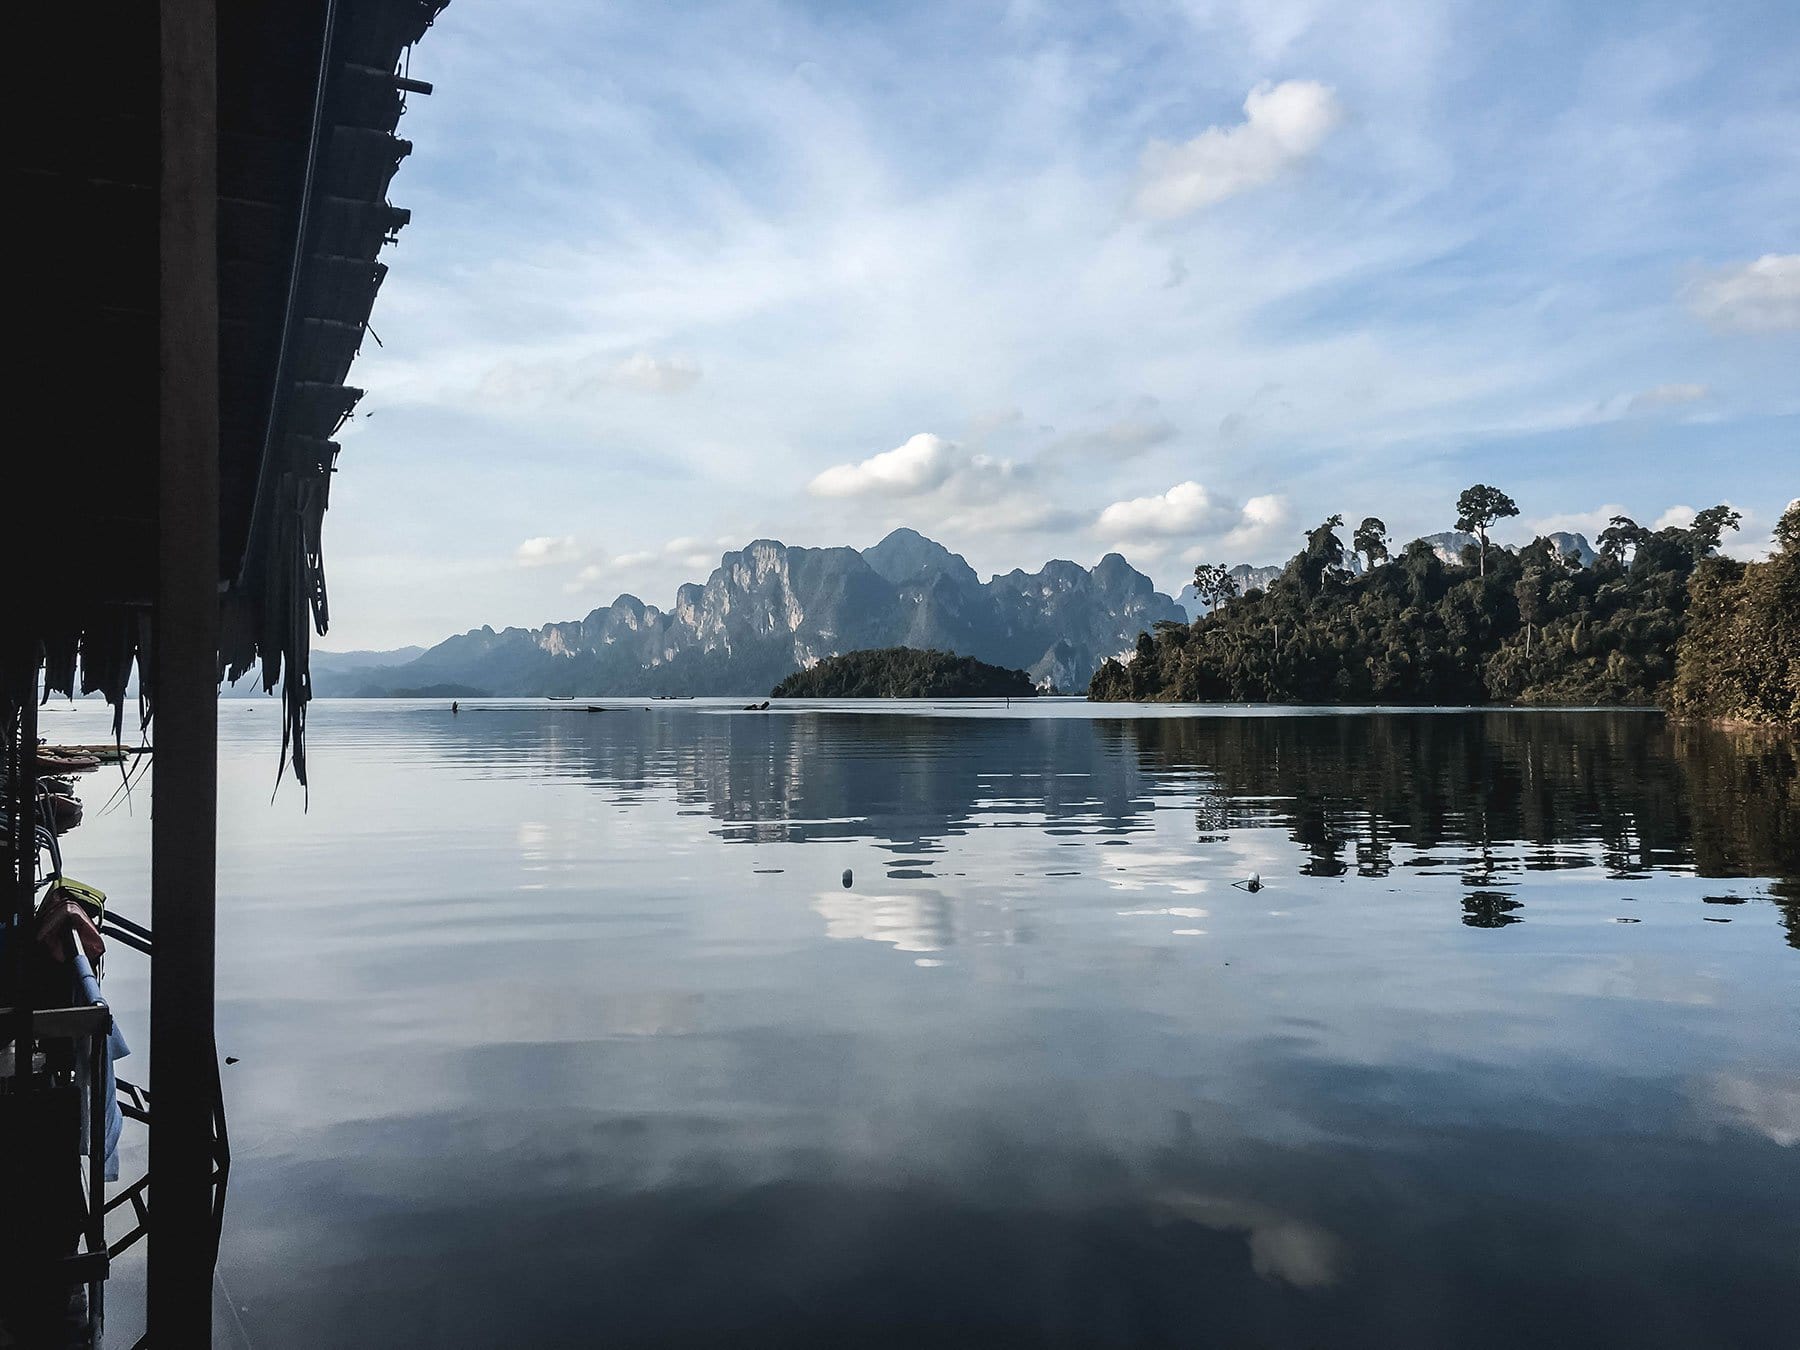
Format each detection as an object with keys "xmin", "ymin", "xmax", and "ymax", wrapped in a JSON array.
[{"xmin": 320, "ymin": 0, "xmax": 1800, "ymax": 650}]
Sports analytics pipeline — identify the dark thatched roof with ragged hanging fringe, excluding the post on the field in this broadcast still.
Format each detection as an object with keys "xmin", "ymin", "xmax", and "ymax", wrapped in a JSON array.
[{"xmin": 18, "ymin": 0, "xmax": 445, "ymax": 781}]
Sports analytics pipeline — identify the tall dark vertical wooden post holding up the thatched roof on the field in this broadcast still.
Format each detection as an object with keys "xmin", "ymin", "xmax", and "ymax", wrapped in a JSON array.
[{"xmin": 149, "ymin": 0, "xmax": 220, "ymax": 1346}]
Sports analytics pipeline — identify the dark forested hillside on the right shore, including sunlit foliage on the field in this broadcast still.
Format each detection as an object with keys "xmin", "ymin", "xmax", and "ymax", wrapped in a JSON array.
[{"xmin": 1089, "ymin": 484, "xmax": 1800, "ymax": 725}]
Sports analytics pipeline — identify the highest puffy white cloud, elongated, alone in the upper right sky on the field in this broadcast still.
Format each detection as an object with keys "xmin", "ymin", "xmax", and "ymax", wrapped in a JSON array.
[{"xmin": 1136, "ymin": 79, "xmax": 1343, "ymax": 220}]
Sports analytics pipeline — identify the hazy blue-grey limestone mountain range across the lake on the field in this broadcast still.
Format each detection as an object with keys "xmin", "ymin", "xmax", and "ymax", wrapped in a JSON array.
[{"xmin": 331, "ymin": 529, "xmax": 1183, "ymax": 695}]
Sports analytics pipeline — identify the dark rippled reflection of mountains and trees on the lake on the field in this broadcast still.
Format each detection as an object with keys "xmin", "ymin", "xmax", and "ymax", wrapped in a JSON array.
[{"xmin": 428, "ymin": 707, "xmax": 1800, "ymax": 950}]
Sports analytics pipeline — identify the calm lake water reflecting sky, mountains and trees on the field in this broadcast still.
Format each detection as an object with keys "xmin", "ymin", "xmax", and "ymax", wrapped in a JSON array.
[{"xmin": 45, "ymin": 702, "xmax": 1800, "ymax": 1350}]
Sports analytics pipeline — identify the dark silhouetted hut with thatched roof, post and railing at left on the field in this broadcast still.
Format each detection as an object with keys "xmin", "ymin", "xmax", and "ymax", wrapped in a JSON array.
[{"xmin": 0, "ymin": 0, "xmax": 445, "ymax": 1346}]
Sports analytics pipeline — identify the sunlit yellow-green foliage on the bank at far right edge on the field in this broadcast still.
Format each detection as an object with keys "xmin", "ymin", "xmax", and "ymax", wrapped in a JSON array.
[{"xmin": 1669, "ymin": 502, "xmax": 1800, "ymax": 725}]
